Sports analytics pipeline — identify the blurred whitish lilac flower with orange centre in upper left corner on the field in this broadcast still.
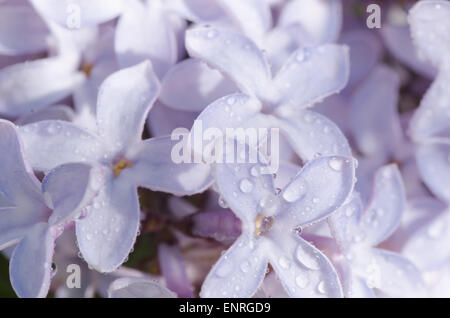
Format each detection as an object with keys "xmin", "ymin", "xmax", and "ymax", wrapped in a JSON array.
[{"xmin": 0, "ymin": 3, "xmax": 114, "ymax": 117}]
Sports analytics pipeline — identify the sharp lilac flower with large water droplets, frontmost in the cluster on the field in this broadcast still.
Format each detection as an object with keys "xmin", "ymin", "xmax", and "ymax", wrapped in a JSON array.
[{"xmin": 200, "ymin": 143, "xmax": 354, "ymax": 297}]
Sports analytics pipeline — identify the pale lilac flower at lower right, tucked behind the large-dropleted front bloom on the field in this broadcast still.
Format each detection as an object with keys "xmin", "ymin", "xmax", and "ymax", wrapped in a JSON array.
[{"xmin": 328, "ymin": 165, "xmax": 422, "ymax": 297}]
